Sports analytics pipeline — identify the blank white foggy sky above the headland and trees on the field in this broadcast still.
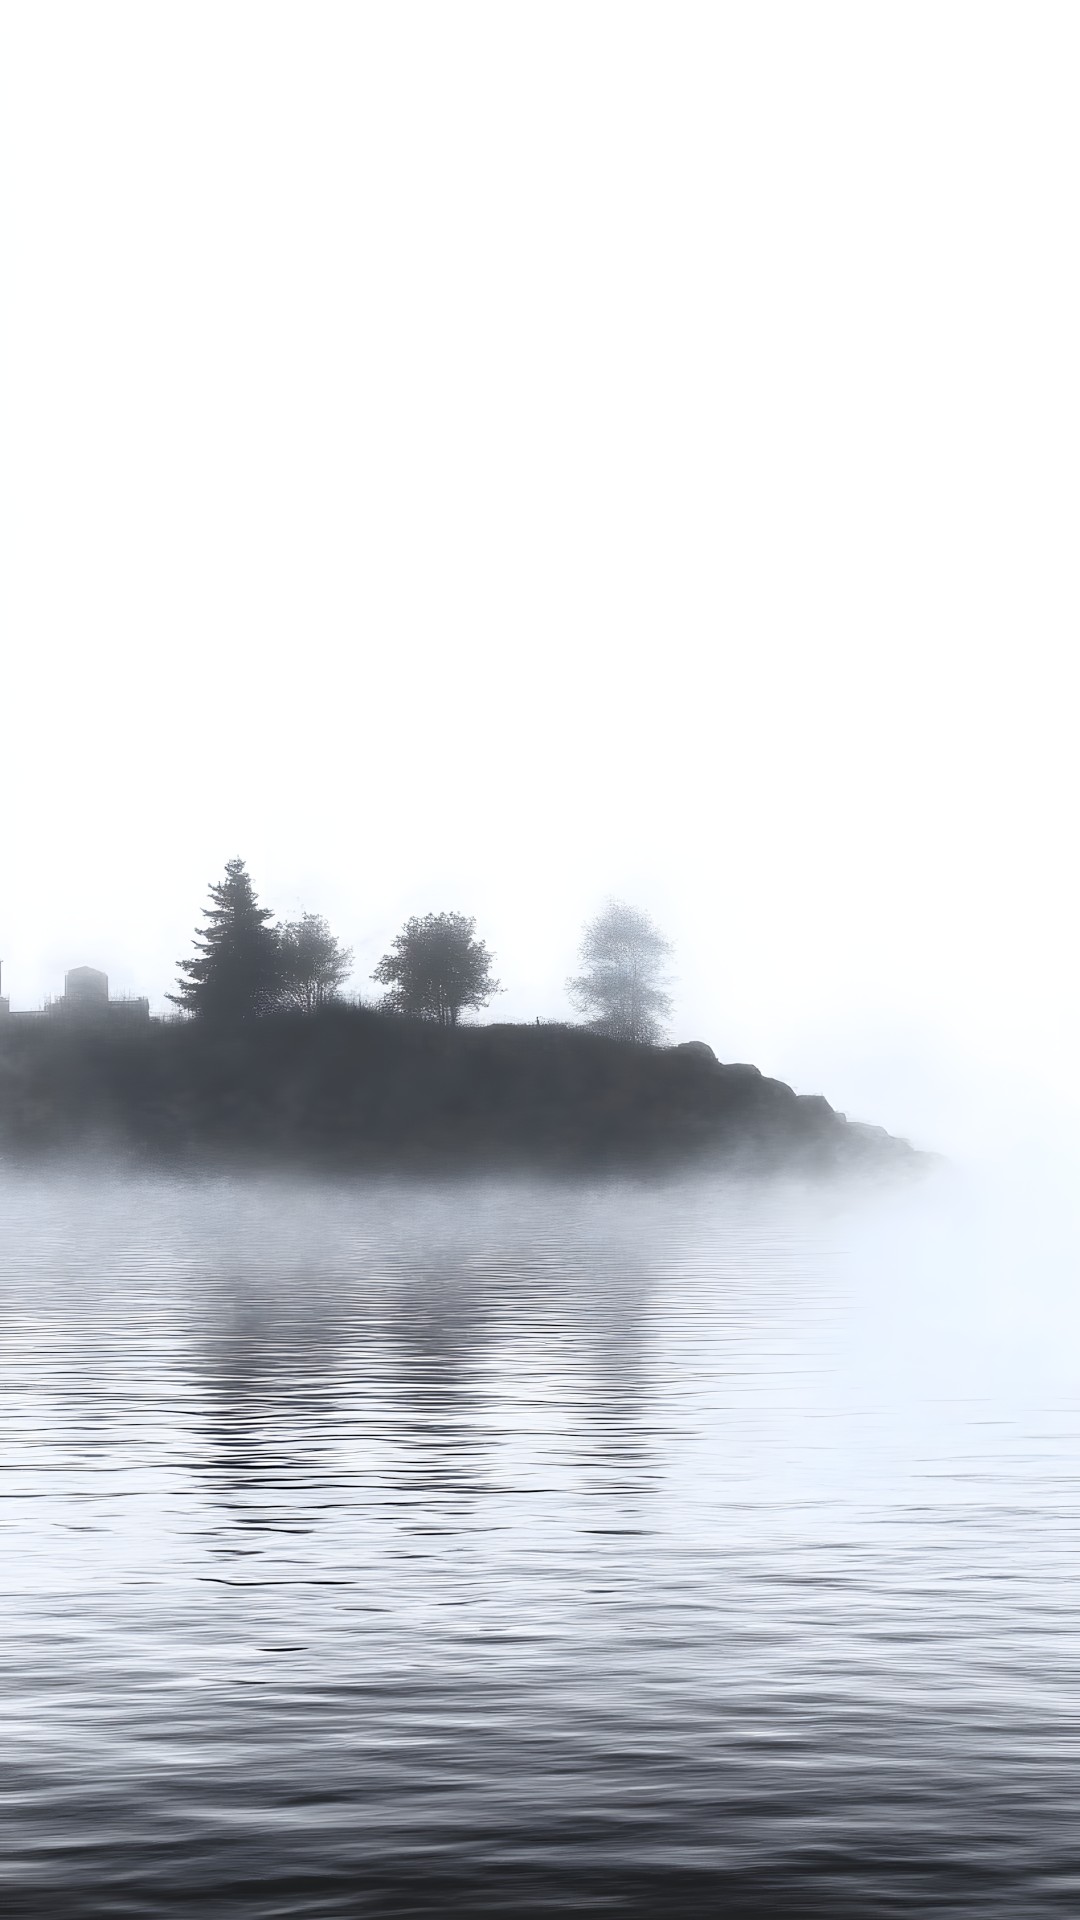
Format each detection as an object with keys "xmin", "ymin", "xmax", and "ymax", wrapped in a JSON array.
[{"xmin": 0, "ymin": 0, "xmax": 1080, "ymax": 1139}]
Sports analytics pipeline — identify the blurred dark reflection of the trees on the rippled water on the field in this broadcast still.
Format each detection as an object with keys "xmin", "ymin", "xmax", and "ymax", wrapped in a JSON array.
[{"xmin": 179, "ymin": 1194, "xmax": 655, "ymax": 1528}]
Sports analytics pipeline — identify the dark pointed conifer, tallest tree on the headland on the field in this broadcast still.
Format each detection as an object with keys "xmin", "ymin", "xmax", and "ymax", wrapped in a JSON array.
[{"xmin": 167, "ymin": 860, "xmax": 279, "ymax": 1020}]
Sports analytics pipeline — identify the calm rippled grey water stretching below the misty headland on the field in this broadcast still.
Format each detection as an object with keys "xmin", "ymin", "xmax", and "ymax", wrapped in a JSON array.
[{"xmin": 0, "ymin": 1175, "xmax": 1080, "ymax": 1920}]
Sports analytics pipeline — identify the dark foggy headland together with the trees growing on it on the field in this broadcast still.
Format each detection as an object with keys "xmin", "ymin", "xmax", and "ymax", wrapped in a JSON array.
[{"xmin": 0, "ymin": 860, "xmax": 919, "ymax": 1171}]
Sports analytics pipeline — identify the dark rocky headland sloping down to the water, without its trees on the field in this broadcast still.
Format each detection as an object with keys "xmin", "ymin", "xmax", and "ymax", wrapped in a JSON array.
[{"xmin": 0, "ymin": 1006, "xmax": 932, "ymax": 1173}]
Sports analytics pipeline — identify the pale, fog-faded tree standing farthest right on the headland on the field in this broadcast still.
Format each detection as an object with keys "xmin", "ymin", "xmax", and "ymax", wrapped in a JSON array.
[{"xmin": 567, "ymin": 900, "xmax": 671, "ymax": 1043}]
